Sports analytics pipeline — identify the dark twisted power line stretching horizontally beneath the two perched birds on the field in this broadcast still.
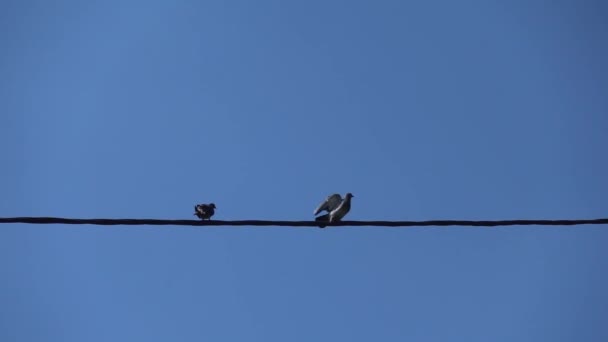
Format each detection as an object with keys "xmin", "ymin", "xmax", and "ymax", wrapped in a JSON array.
[{"xmin": 0, "ymin": 217, "xmax": 608, "ymax": 227}]
